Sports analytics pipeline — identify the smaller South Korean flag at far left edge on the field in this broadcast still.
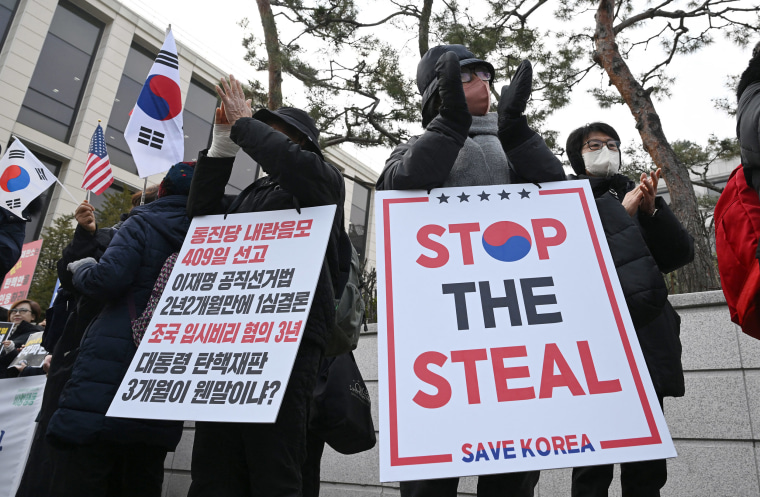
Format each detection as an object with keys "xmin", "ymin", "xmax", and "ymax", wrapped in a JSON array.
[{"xmin": 0, "ymin": 139, "xmax": 56, "ymax": 218}]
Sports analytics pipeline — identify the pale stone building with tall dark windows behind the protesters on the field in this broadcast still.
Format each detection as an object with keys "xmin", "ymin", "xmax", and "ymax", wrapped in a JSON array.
[{"xmin": 0, "ymin": 0, "xmax": 377, "ymax": 280}]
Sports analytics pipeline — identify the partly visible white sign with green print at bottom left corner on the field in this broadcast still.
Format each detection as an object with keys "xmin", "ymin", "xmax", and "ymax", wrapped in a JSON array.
[{"xmin": 0, "ymin": 375, "xmax": 47, "ymax": 497}]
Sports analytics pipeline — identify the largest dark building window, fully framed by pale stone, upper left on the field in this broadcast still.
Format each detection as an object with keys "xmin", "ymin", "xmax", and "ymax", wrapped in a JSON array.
[{"xmin": 18, "ymin": 3, "xmax": 104, "ymax": 142}]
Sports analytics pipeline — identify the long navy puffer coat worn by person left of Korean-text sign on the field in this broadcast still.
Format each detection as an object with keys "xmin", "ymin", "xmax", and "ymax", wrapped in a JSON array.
[{"xmin": 47, "ymin": 195, "xmax": 190, "ymax": 451}]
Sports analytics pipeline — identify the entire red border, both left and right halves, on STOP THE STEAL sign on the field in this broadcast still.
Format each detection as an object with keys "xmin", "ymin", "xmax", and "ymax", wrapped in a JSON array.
[{"xmin": 383, "ymin": 188, "xmax": 662, "ymax": 466}]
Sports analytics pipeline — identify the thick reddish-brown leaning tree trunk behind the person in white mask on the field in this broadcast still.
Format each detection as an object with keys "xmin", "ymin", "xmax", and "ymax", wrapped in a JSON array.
[{"xmin": 594, "ymin": 0, "xmax": 720, "ymax": 292}]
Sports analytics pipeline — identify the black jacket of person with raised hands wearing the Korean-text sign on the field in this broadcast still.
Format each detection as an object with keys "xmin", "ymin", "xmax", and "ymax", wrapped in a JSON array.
[{"xmin": 187, "ymin": 118, "xmax": 346, "ymax": 350}]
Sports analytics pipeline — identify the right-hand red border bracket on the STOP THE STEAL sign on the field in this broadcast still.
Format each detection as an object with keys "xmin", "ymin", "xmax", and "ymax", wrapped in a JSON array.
[{"xmin": 538, "ymin": 188, "xmax": 662, "ymax": 449}]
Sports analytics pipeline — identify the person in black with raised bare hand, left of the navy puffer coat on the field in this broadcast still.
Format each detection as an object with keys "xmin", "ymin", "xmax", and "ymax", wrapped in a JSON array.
[{"xmin": 16, "ymin": 186, "xmax": 158, "ymax": 497}]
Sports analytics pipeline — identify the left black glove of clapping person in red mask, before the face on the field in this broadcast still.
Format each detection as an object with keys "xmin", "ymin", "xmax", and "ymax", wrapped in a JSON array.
[{"xmin": 435, "ymin": 52, "xmax": 472, "ymax": 134}]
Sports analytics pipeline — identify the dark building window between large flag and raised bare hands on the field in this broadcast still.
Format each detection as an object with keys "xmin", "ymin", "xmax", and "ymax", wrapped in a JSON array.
[{"xmin": 182, "ymin": 81, "xmax": 217, "ymax": 160}]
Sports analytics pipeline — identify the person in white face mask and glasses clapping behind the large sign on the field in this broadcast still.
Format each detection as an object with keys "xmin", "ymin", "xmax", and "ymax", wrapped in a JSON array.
[{"xmin": 513, "ymin": 122, "xmax": 694, "ymax": 497}]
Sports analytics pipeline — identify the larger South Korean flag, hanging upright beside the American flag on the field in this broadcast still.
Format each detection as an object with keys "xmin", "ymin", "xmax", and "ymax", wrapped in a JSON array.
[{"xmin": 124, "ymin": 29, "xmax": 185, "ymax": 178}]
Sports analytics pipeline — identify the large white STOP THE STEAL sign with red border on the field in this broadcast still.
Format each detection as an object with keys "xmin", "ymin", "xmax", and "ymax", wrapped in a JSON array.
[{"xmin": 376, "ymin": 181, "xmax": 675, "ymax": 481}]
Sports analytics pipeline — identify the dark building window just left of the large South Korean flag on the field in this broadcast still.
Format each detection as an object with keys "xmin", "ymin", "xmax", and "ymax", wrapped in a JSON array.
[{"xmin": 105, "ymin": 45, "xmax": 155, "ymax": 174}]
